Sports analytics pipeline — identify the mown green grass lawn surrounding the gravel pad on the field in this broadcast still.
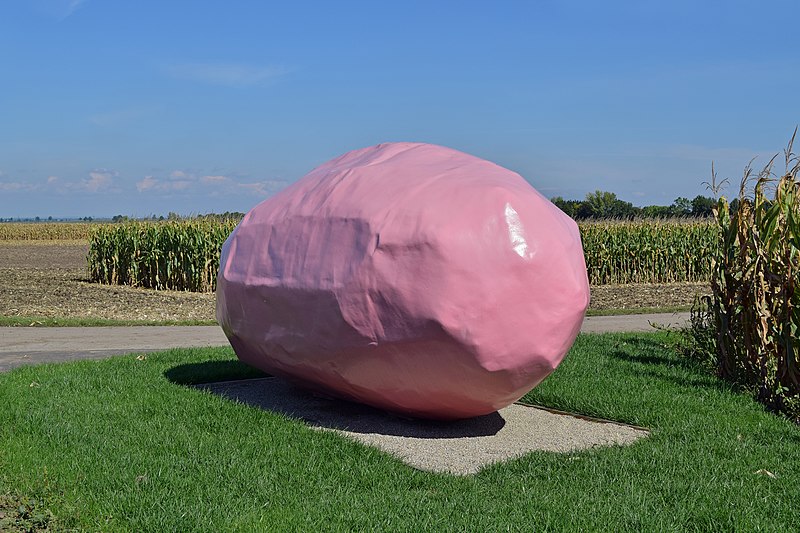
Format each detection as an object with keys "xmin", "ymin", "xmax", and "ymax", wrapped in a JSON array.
[{"xmin": 0, "ymin": 333, "xmax": 800, "ymax": 531}]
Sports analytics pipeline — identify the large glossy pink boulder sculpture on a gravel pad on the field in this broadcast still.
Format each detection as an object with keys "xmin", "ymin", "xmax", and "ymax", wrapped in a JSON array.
[{"xmin": 217, "ymin": 143, "xmax": 589, "ymax": 419}]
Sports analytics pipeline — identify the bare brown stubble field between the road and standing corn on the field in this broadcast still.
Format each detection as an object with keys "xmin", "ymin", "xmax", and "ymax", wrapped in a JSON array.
[{"xmin": 0, "ymin": 241, "xmax": 709, "ymax": 320}]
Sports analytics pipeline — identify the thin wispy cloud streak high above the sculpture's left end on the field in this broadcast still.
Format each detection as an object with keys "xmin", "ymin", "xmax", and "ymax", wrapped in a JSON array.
[{"xmin": 165, "ymin": 63, "xmax": 286, "ymax": 87}]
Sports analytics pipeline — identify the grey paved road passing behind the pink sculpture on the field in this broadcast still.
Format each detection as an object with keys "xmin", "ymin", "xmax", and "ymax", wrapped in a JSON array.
[{"xmin": 0, "ymin": 313, "xmax": 689, "ymax": 372}]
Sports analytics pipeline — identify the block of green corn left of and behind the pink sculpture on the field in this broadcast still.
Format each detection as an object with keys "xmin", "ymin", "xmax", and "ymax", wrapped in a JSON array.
[{"xmin": 88, "ymin": 220, "xmax": 237, "ymax": 292}]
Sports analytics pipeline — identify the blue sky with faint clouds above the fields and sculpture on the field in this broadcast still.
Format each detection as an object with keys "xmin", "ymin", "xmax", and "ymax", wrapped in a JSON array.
[{"xmin": 0, "ymin": 0, "xmax": 800, "ymax": 217}]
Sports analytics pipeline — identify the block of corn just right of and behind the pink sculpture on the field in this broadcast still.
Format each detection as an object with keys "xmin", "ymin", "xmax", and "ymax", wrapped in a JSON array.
[{"xmin": 579, "ymin": 219, "xmax": 717, "ymax": 285}]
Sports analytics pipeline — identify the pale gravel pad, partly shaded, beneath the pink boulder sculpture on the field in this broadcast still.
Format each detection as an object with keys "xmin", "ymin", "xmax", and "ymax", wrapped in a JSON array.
[{"xmin": 197, "ymin": 378, "xmax": 648, "ymax": 475}]
